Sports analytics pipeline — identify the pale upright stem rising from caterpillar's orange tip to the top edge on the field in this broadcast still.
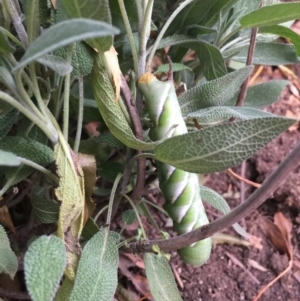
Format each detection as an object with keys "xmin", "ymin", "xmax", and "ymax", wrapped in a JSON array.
[{"xmin": 138, "ymin": 0, "xmax": 154, "ymax": 77}]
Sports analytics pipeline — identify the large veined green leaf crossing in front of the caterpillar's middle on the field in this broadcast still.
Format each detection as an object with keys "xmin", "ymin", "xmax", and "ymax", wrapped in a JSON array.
[{"xmin": 154, "ymin": 117, "xmax": 295, "ymax": 173}]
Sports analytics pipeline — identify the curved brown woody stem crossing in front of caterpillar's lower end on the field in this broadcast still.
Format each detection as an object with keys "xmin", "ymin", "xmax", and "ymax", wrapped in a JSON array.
[{"xmin": 123, "ymin": 138, "xmax": 300, "ymax": 252}]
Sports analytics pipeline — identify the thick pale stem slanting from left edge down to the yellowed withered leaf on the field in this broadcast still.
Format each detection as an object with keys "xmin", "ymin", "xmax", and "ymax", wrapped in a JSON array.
[{"xmin": 0, "ymin": 91, "xmax": 57, "ymax": 143}]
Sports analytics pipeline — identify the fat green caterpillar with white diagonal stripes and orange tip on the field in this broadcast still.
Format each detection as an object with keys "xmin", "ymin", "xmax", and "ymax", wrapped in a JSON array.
[{"xmin": 138, "ymin": 73, "xmax": 211, "ymax": 266}]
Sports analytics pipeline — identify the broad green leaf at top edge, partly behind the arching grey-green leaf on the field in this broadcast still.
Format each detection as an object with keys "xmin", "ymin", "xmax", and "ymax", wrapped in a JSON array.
[{"xmin": 61, "ymin": 0, "xmax": 113, "ymax": 51}]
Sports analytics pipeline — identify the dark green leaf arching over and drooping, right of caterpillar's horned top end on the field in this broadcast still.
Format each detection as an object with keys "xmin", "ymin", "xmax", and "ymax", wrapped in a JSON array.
[{"xmin": 154, "ymin": 35, "xmax": 227, "ymax": 80}]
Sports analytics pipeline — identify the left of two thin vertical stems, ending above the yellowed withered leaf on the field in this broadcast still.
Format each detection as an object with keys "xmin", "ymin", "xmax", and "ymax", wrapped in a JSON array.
[{"xmin": 63, "ymin": 44, "xmax": 73, "ymax": 142}]
